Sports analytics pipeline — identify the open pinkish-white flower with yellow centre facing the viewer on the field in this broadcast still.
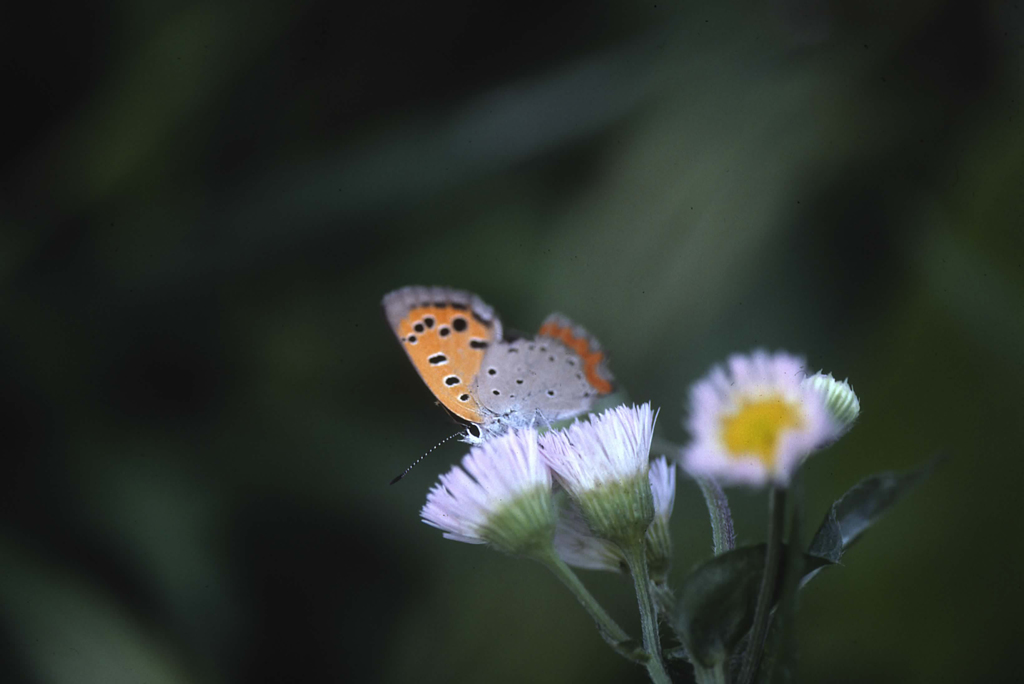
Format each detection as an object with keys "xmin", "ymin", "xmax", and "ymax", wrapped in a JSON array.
[{"xmin": 683, "ymin": 351, "xmax": 841, "ymax": 486}]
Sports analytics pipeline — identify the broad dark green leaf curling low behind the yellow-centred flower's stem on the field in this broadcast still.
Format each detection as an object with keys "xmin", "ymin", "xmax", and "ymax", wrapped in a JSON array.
[{"xmin": 673, "ymin": 544, "xmax": 827, "ymax": 668}]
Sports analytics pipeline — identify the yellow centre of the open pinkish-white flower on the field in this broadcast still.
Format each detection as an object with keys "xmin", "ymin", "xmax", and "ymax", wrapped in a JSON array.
[{"xmin": 722, "ymin": 396, "xmax": 804, "ymax": 468}]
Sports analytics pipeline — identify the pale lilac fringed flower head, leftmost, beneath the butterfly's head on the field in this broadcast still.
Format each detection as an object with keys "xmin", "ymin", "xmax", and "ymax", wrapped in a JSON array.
[{"xmin": 420, "ymin": 428, "xmax": 557, "ymax": 555}]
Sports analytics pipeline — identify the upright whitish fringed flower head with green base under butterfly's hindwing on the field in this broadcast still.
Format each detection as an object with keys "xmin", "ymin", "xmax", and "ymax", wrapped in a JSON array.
[{"xmin": 541, "ymin": 403, "xmax": 655, "ymax": 548}]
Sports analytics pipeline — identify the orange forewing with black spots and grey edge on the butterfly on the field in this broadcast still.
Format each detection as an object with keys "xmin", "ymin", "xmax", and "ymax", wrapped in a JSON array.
[{"xmin": 382, "ymin": 286, "xmax": 502, "ymax": 424}]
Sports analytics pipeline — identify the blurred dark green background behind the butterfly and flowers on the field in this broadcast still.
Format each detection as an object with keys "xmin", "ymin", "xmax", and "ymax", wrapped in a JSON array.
[{"xmin": 0, "ymin": 0, "xmax": 1024, "ymax": 684}]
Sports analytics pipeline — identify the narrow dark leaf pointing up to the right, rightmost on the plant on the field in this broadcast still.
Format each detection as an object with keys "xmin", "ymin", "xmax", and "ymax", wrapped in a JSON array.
[{"xmin": 807, "ymin": 459, "xmax": 940, "ymax": 563}]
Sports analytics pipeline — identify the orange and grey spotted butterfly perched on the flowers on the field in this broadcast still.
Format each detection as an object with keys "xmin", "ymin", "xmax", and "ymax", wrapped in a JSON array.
[{"xmin": 382, "ymin": 286, "xmax": 614, "ymax": 442}]
